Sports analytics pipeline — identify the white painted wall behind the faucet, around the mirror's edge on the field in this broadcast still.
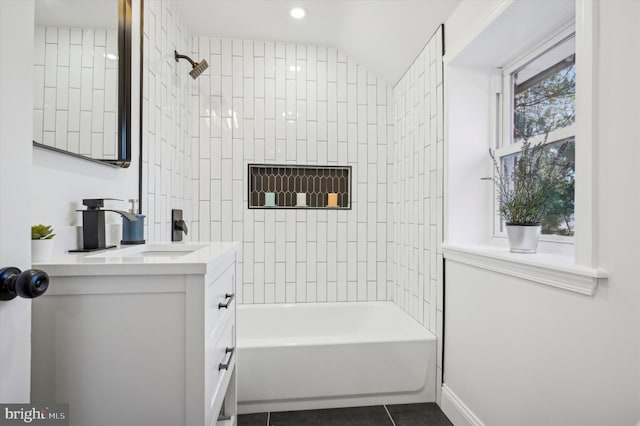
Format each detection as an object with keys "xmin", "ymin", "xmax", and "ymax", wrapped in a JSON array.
[{"xmin": 31, "ymin": 0, "xmax": 140, "ymax": 253}]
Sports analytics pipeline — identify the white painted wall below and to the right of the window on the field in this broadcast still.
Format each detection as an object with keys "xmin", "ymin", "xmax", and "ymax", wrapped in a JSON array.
[{"xmin": 444, "ymin": 1, "xmax": 640, "ymax": 426}]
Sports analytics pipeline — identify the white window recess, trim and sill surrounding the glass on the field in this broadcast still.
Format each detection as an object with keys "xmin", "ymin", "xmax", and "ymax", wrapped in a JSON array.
[{"xmin": 442, "ymin": 1, "xmax": 607, "ymax": 295}]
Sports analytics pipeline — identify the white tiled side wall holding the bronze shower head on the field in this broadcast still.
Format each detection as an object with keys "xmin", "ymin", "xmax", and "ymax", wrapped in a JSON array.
[{"xmin": 141, "ymin": 0, "xmax": 195, "ymax": 241}]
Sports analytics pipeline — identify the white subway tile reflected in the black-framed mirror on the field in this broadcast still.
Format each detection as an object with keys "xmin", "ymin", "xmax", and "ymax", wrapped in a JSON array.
[{"xmin": 33, "ymin": 27, "xmax": 118, "ymax": 159}]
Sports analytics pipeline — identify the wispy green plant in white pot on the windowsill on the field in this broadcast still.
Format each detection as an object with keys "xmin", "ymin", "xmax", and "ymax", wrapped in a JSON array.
[{"xmin": 489, "ymin": 140, "xmax": 571, "ymax": 253}]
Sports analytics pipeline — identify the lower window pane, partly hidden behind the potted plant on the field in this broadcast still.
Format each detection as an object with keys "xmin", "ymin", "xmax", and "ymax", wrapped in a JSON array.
[{"xmin": 500, "ymin": 137, "xmax": 575, "ymax": 236}]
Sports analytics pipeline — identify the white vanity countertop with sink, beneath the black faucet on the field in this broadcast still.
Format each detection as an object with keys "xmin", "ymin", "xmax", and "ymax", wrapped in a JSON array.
[{"xmin": 33, "ymin": 241, "xmax": 240, "ymax": 277}]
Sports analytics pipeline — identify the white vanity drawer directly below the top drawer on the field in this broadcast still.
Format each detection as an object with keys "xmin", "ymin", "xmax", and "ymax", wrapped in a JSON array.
[{"xmin": 205, "ymin": 318, "xmax": 237, "ymax": 424}]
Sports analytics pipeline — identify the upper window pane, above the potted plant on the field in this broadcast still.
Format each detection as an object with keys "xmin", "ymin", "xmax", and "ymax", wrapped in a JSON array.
[{"xmin": 512, "ymin": 38, "xmax": 576, "ymax": 143}]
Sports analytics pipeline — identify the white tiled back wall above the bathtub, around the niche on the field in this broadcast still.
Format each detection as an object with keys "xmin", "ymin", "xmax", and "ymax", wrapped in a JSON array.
[{"xmin": 186, "ymin": 37, "xmax": 393, "ymax": 303}]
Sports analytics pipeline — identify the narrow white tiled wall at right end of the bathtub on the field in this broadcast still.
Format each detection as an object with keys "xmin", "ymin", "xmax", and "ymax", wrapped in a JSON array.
[{"xmin": 387, "ymin": 27, "xmax": 444, "ymax": 388}]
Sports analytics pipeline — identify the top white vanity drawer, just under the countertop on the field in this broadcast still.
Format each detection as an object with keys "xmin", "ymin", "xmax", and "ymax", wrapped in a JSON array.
[{"xmin": 205, "ymin": 265, "xmax": 236, "ymax": 340}]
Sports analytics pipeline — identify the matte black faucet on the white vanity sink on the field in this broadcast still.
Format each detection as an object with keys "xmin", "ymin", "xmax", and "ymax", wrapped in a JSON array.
[{"xmin": 69, "ymin": 198, "xmax": 138, "ymax": 252}]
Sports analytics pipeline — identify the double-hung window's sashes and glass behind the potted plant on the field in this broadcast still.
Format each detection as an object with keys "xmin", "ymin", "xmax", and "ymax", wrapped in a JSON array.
[{"xmin": 496, "ymin": 34, "xmax": 576, "ymax": 240}]
